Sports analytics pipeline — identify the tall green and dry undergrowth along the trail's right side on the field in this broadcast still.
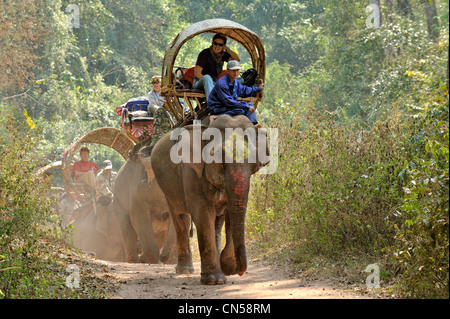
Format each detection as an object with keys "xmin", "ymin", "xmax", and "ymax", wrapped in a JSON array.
[{"xmin": 247, "ymin": 43, "xmax": 449, "ymax": 298}]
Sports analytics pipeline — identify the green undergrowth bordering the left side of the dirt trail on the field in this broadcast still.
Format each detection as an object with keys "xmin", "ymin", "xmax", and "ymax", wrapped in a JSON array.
[{"xmin": 0, "ymin": 118, "xmax": 110, "ymax": 299}]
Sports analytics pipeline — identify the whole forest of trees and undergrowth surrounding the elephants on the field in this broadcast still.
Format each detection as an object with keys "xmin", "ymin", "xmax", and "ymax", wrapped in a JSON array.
[{"xmin": 0, "ymin": 0, "xmax": 449, "ymax": 299}]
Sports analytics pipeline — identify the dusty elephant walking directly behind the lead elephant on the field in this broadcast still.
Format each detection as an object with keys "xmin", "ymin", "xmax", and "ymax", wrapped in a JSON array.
[{"xmin": 114, "ymin": 155, "xmax": 177, "ymax": 264}]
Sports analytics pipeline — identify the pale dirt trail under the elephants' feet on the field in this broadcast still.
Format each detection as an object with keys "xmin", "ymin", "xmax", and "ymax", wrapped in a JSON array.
[{"xmin": 98, "ymin": 261, "xmax": 369, "ymax": 299}]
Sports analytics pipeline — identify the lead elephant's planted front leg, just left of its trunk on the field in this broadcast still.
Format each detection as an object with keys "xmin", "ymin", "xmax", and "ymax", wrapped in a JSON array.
[{"xmin": 194, "ymin": 205, "xmax": 227, "ymax": 285}]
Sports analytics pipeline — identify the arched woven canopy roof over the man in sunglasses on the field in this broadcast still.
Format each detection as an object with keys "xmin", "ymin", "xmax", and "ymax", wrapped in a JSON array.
[{"xmin": 162, "ymin": 19, "xmax": 266, "ymax": 86}]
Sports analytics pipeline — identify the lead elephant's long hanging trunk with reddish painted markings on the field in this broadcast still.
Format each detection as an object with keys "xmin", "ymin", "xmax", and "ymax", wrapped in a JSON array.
[{"xmin": 225, "ymin": 164, "xmax": 251, "ymax": 276}]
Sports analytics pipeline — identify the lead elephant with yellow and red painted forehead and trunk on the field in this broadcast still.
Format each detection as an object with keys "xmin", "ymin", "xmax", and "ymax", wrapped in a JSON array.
[{"xmin": 151, "ymin": 115, "xmax": 269, "ymax": 285}]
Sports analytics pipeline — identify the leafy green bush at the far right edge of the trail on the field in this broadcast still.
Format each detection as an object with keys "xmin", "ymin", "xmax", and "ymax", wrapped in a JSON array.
[{"xmin": 384, "ymin": 48, "xmax": 449, "ymax": 298}]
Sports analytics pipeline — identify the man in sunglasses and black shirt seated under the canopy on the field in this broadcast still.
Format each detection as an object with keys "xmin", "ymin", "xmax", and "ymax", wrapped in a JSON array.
[{"xmin": 193, "ymin": 33, "xmax": 241, "ymax": 98}]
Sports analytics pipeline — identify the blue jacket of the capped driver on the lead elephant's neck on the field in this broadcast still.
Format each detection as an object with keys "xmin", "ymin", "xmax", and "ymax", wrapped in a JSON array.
[{"xmin": 207, "ymin": 74, "xmax": 261, "ymax": 116}]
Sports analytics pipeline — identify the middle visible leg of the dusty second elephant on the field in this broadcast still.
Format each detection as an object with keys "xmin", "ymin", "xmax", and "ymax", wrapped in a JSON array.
[{"xmin": 131, "ymin": 207, "xmax": 159, "ymax": 264}]
